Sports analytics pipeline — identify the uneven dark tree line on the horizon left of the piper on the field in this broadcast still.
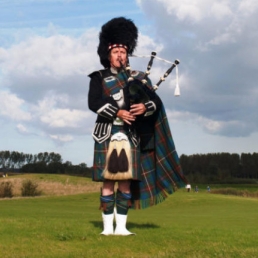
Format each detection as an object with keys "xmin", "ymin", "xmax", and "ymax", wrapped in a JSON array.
[{"xmin": 0, "ymin": 151, "xmax": 91, "ymax": 176}]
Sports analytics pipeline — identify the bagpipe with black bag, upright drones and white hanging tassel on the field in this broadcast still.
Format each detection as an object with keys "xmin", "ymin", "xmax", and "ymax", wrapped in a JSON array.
[{"xmin": 120, "ymin": 51, "xmax": 180, "ymax": 104}]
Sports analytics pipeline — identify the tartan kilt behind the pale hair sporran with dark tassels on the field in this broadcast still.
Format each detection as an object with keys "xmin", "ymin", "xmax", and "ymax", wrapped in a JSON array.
[{"xmin": 92, "ymin": 126, "xmax": 141, "ymax": 182}]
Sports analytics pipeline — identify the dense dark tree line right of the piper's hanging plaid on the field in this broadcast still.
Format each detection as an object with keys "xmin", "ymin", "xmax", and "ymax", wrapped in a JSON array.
[{"xmin": 180, "ymin": 153, "xmax": 258, "ymax": 183}]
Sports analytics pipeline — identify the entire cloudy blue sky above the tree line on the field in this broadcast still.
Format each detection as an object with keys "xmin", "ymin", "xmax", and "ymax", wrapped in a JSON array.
[{"xmin": 0, "ymin": 0, "xmax": 258, "ymax": 166}]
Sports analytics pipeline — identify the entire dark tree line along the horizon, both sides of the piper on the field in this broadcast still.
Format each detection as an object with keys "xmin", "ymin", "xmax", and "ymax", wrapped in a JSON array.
[{"xmin": 0, "ymin": 151, "xmax": 258, "ymax": 183}]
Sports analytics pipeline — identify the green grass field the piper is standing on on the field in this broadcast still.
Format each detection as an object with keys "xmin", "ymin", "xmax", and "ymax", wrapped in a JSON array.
[{"xmin": 0, "ymin": 175, "xmax": 258, "ymax": 258}]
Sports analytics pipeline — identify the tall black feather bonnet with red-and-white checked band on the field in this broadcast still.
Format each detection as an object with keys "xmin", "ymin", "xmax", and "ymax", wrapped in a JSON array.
[{"xmin": 98, "ymin": 17, "xmax": 138, "ymax": 68}]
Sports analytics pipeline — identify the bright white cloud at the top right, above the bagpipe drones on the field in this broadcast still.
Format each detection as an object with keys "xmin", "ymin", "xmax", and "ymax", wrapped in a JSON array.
[{"xmin": 137, "ymin": 0, "xmax": 258, "ymax": 51}]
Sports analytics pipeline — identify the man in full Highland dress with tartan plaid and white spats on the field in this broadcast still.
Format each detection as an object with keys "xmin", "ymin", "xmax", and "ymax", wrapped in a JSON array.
[{"xmin": 88, "ymin": 17, "xmax": 185, "ymax": 235}]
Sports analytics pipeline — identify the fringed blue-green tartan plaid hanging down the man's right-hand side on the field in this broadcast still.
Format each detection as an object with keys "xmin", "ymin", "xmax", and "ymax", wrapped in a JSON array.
[{"xmin": 131, "ymin": 104, "xmax": 187, "ymax": 209}]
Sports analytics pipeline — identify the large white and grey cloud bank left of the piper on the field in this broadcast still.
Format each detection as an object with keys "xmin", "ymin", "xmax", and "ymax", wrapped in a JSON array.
[{"xmin": 0, "ymin": 29, "xmax": 100, "ymax": 146}]
